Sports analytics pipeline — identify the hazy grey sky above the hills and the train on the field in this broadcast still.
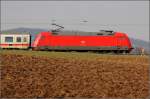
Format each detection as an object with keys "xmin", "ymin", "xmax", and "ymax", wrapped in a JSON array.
[{"xmin": 1, "ymin": 1, "xmax": 149, "ymax": 41}]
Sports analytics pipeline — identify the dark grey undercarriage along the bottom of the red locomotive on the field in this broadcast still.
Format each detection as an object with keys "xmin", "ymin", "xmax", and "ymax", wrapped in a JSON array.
[{"xmin": 32, "ymin": 46, "xmax": 130, "ymax": 54}]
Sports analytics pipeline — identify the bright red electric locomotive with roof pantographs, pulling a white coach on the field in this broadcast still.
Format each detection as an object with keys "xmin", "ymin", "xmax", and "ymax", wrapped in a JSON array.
[{"xmin": 32, "ymin": 24, "xmax": 132, "ymax": 53}]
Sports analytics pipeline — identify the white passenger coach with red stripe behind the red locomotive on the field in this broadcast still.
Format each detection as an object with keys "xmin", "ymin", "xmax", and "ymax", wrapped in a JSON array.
[{"xmin": 0, "ymin": 33, "xmax": 31, "ymax": 49}]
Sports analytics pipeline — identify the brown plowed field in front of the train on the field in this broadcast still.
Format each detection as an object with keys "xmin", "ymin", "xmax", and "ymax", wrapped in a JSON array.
[{"xmin": 0, "ymin": 52, "xmax": 149, "ymax": 98}]
